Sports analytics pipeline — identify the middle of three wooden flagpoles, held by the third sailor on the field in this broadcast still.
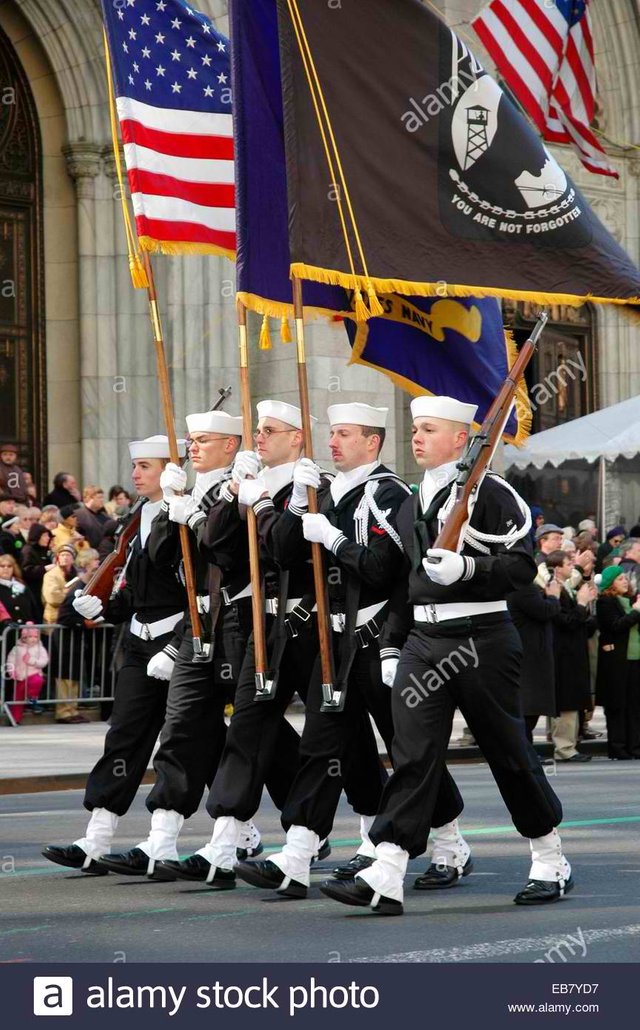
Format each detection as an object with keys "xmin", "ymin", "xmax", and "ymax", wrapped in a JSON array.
[{"xmin": 236, "ymin": 300, "xmax": 272, "ymax": 698}]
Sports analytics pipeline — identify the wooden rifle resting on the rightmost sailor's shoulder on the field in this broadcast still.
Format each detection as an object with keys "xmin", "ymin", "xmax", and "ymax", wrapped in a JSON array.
[{"xmin": 428, "ymin": 311, "xmax": 548, "ymax": 564}]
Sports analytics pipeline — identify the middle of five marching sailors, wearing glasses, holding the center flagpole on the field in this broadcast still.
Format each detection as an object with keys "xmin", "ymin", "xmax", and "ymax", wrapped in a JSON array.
[{"xmin": 155, "ymin": 400, "xmax": 380, "ymax": 888}]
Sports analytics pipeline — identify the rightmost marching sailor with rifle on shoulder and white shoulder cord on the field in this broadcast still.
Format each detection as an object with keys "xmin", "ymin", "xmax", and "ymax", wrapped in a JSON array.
[{"xmin": 321, "ymin": 397, "xmax": 573, "ymax": 915}]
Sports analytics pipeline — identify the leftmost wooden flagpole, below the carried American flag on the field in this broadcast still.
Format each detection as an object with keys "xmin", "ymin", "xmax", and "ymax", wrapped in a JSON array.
[{"xmin": 142, "ymin": 251, "xmax": 205, "ymax": 661}]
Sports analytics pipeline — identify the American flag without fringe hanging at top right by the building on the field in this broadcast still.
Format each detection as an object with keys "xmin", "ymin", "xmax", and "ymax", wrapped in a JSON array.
[{"xmin": 471, "ymin": 0, "xmax": 618, "ymax": 178}]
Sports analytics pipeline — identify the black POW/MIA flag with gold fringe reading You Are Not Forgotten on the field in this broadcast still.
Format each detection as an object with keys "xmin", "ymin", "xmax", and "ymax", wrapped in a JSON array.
[{"xmin": 276, "ymin": 0, "xmax": 640, "ymax": 303}]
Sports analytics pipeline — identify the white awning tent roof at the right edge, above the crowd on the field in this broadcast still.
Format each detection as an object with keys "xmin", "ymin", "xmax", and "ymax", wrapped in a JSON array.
[{"xmin": 504, "ymin": 397, "xmax": 640, "ymax": 469}]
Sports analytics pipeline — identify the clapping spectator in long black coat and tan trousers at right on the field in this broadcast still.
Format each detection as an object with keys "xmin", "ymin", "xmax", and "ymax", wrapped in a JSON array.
[{"xmin": 545, "ymin": 550, "xmax": 596, "ymax": 762}]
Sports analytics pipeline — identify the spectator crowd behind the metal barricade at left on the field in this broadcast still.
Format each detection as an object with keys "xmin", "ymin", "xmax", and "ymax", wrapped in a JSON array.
[{"xmin": 0, "ymin": 444, "xmax": 133, "ymax": 724}]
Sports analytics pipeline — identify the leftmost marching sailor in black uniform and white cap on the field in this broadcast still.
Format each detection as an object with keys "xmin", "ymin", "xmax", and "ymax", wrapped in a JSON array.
[{"xmin": 42, "ymin": 436, "xmax": 187, "ymax": 876}]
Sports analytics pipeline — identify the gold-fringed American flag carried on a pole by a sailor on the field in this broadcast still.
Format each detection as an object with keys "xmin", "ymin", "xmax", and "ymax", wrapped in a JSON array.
[{"xmin": 102, "ymin": 0, "xmax": 236, "ymax": 258}]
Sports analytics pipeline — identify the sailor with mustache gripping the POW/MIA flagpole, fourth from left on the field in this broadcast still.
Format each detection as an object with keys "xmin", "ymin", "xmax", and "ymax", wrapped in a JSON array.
[{"xmin": 236, "ymin": 404, "xmax": 462, "ymax": 897}]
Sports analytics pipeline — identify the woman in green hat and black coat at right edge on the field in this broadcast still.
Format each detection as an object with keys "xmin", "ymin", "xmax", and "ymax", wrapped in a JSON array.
[{"xmin": 596, "ymin": 565, "xmax": 640, "ymax": 759}]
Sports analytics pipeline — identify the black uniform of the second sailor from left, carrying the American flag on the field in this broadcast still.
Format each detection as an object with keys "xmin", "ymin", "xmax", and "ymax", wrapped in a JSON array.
[{"xmin": 146, "ymin": 470, "xmax": 298, "ymax": 819}]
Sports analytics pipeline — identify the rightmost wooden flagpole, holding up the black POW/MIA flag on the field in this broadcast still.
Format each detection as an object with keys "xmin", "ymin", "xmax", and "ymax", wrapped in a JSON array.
[{"xmin": 293, "ymin": 276, "xmax": 335, "ymax": 712}]
